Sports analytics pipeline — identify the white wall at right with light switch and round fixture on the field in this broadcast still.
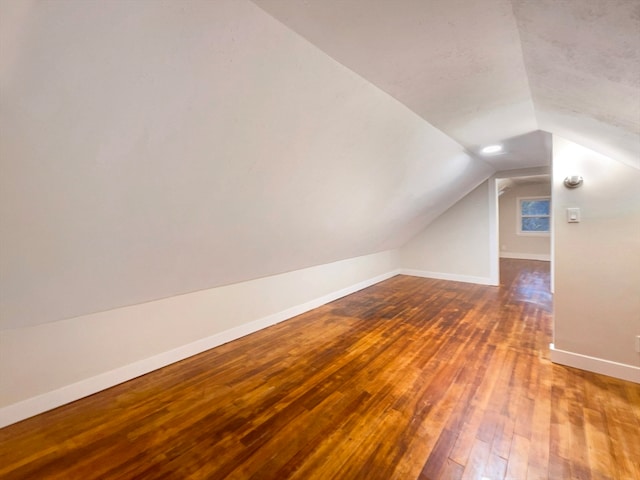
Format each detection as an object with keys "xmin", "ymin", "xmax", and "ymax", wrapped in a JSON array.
[{"xmin": 552, "ymin": 136, "xmax": 640, "ymax": 382}]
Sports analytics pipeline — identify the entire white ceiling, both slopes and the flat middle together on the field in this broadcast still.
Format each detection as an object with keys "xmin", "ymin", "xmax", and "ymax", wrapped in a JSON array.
[{"xmin": 0, "ymin": 0, "xmax": 640, "ymax": 328}]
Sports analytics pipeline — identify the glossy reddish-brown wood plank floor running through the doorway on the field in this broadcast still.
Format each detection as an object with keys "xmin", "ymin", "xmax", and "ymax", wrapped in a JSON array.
[{"xmin": 0, "ymin": 260, "xmax": 640, "ymax": 480}]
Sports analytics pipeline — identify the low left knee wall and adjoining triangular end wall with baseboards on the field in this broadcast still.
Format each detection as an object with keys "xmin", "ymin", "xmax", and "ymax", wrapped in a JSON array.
[{"xmin": 0, "ymin": 176, "xmax": 497, "ymax": 426}]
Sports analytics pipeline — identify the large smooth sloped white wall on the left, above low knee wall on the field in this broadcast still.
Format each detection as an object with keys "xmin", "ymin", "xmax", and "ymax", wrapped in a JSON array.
[{"xmin": 0, "ymin": 0, "xmax": 492, "ymax": 328}]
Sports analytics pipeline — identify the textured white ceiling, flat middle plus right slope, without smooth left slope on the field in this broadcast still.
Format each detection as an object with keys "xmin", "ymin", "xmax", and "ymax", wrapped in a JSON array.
[{"xmin": 253, "ymin": 0, "xmax": 640, "ymax": 170}]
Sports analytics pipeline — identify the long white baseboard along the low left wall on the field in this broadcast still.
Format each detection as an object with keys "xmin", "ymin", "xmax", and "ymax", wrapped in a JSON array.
[{"xmin": 0, "ymin": 270, "xmax": 400, "ymax": 428}]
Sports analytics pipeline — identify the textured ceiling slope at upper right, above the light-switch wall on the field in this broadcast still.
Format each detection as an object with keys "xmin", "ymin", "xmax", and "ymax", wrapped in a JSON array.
[{"xmin": 513, "ymin": 0, "xmax": 640, "ymax": 168}]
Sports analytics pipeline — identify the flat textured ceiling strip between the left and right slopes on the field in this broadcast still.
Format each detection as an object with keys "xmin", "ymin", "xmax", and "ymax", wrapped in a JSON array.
[{"xmin": 255, "ymin": 0, "xmax": 537, "ymax": 158}]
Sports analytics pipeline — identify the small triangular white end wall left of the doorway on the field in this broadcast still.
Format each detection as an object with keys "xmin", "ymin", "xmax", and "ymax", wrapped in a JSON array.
[{"xmin": 399, "ymin": 181, "xmax": 497, "ymax": 284}]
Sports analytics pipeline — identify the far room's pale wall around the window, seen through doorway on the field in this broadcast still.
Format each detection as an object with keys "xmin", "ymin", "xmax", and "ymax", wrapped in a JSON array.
[{"xmin": 498, "ymin": 181, "xmax": 551, "ymax": 260}]
